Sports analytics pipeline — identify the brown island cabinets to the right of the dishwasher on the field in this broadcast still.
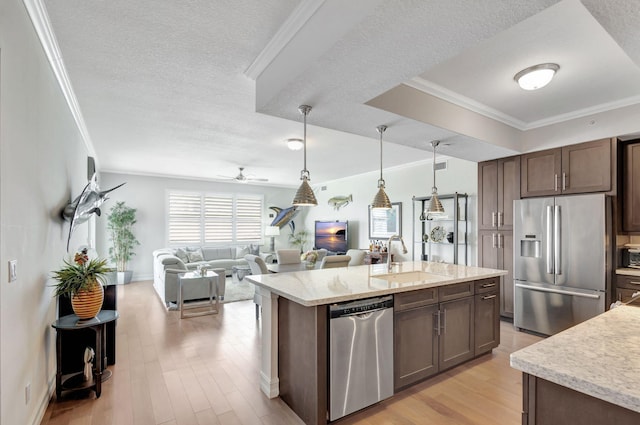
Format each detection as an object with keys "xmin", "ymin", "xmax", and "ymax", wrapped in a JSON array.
[{"xmin": 394, "ymin": 278, "xmax": 500, "ymax": 391}]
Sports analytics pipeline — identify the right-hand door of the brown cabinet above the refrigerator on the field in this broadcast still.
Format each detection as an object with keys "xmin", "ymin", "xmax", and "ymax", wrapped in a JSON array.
[{"xmin": 560, "ymin": 139, "xmax": 611, "ymax": 194}]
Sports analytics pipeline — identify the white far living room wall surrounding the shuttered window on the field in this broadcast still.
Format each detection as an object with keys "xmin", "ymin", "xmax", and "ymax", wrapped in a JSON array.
[{"xmin": 96, "ymin": 172, "xmax": 298, "ymax": 280}]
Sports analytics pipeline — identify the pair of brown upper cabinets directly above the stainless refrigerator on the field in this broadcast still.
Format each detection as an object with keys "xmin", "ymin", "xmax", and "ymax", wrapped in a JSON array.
[{"xmin": 520, "ymin": 139, "xmax": 615, "ymax": 198}]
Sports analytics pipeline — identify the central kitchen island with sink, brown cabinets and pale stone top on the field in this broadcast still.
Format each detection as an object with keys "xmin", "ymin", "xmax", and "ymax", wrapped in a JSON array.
[{"xmin": 246, "ymin": 261, "xmax": 506, "ymax": 424}]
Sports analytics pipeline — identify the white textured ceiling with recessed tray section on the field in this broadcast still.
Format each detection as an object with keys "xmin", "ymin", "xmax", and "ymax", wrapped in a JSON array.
[{"xmin": 44, "ymin": 0, "xmax": 640, "ymax": 186}]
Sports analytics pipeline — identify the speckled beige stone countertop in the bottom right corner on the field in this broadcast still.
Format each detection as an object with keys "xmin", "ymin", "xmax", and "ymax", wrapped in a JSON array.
[{"xmin": 511, "ymin": 305, "xmax": 640, "ymax": 412}]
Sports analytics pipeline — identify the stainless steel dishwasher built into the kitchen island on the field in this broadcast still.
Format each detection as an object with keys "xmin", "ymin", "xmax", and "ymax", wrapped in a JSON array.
[{"xmin": 329, "ymin": 295, "xmax": 393, "ymax": 421}]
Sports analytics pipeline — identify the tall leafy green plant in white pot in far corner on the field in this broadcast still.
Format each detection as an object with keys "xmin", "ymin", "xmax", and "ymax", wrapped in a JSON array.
[{"xmin": 107, "ymin": 202, "xmax": 140, "ymax": 284}]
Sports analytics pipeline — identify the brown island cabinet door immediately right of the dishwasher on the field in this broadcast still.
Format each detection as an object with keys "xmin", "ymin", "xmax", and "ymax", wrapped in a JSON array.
[{"xmin": 393, "ymin": 304, "xmax": 438, "ymax": 391}]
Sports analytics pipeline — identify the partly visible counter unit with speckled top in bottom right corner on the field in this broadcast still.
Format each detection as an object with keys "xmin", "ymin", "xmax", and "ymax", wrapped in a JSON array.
[{"xmin": 511, "ymin": 305, "xmax": 640, "ymax": 425}]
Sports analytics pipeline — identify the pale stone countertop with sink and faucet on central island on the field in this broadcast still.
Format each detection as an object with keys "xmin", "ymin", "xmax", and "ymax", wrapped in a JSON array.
[{"xmin": 245, "ymin": 261, "xmax": 507, "ymax": 307}]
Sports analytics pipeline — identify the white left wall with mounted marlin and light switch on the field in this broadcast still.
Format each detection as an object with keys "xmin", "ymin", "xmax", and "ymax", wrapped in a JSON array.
[{"xmin": 0, "ymin": 0, "xmax": 88, "ymax": 424}]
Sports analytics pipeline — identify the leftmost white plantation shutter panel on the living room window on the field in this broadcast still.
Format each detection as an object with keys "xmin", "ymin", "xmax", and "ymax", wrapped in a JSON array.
[{"xmin": 169, "ymin": 193, "xmax": 202, "ymax": 244}]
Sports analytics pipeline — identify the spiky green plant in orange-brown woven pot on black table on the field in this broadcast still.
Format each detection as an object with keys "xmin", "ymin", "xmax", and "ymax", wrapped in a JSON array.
[{"xmin": 53, "ymin": 250, "xmax": 111, "ymax": 319}]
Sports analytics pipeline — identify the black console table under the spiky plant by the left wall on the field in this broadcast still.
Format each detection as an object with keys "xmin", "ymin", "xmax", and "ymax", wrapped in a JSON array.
[{"xmin": 51, "ymin": 310, "xmax": 118, "ymax": 399}]
